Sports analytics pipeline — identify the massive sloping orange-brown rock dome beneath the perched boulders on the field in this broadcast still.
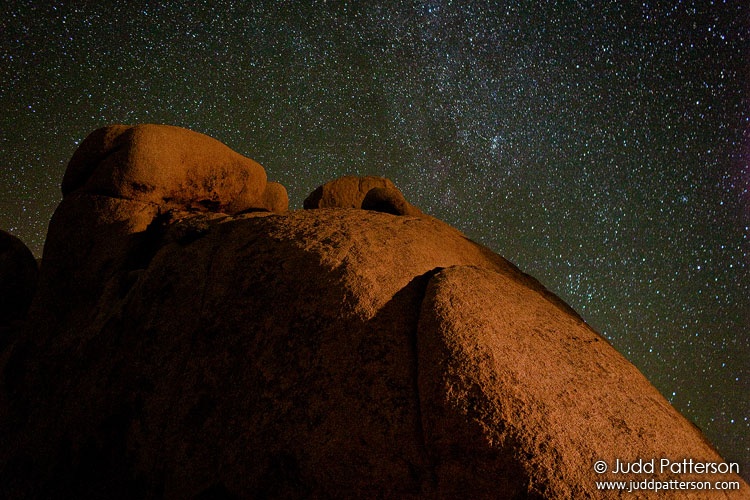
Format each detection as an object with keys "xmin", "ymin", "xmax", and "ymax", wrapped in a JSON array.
[{"xmin": 0, "ymin": 126, "xmax": 748, "ymax": 499}]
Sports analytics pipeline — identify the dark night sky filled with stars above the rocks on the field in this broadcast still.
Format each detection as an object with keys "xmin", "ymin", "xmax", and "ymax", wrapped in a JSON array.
[{"xmin": 0, "ymin": 0, "xmax": 750, "ymax": 477}]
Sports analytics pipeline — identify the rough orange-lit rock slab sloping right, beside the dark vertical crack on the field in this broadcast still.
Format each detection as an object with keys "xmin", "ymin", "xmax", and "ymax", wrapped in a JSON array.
[{"xmin": 418, "ymin": 266, "xmax": 747, "ymax": 499}]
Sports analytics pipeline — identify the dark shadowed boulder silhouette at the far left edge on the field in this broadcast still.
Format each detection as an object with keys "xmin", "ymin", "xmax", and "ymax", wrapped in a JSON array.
[{"xmin": 0, "ymin": 231, "xmax": 39, "ymax": 325}]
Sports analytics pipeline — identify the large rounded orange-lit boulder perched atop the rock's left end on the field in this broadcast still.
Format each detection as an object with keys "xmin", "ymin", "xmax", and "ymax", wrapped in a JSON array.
[{"xmin": 62, "ymin": 124, "xmax": 286, "ymax": 212}]
